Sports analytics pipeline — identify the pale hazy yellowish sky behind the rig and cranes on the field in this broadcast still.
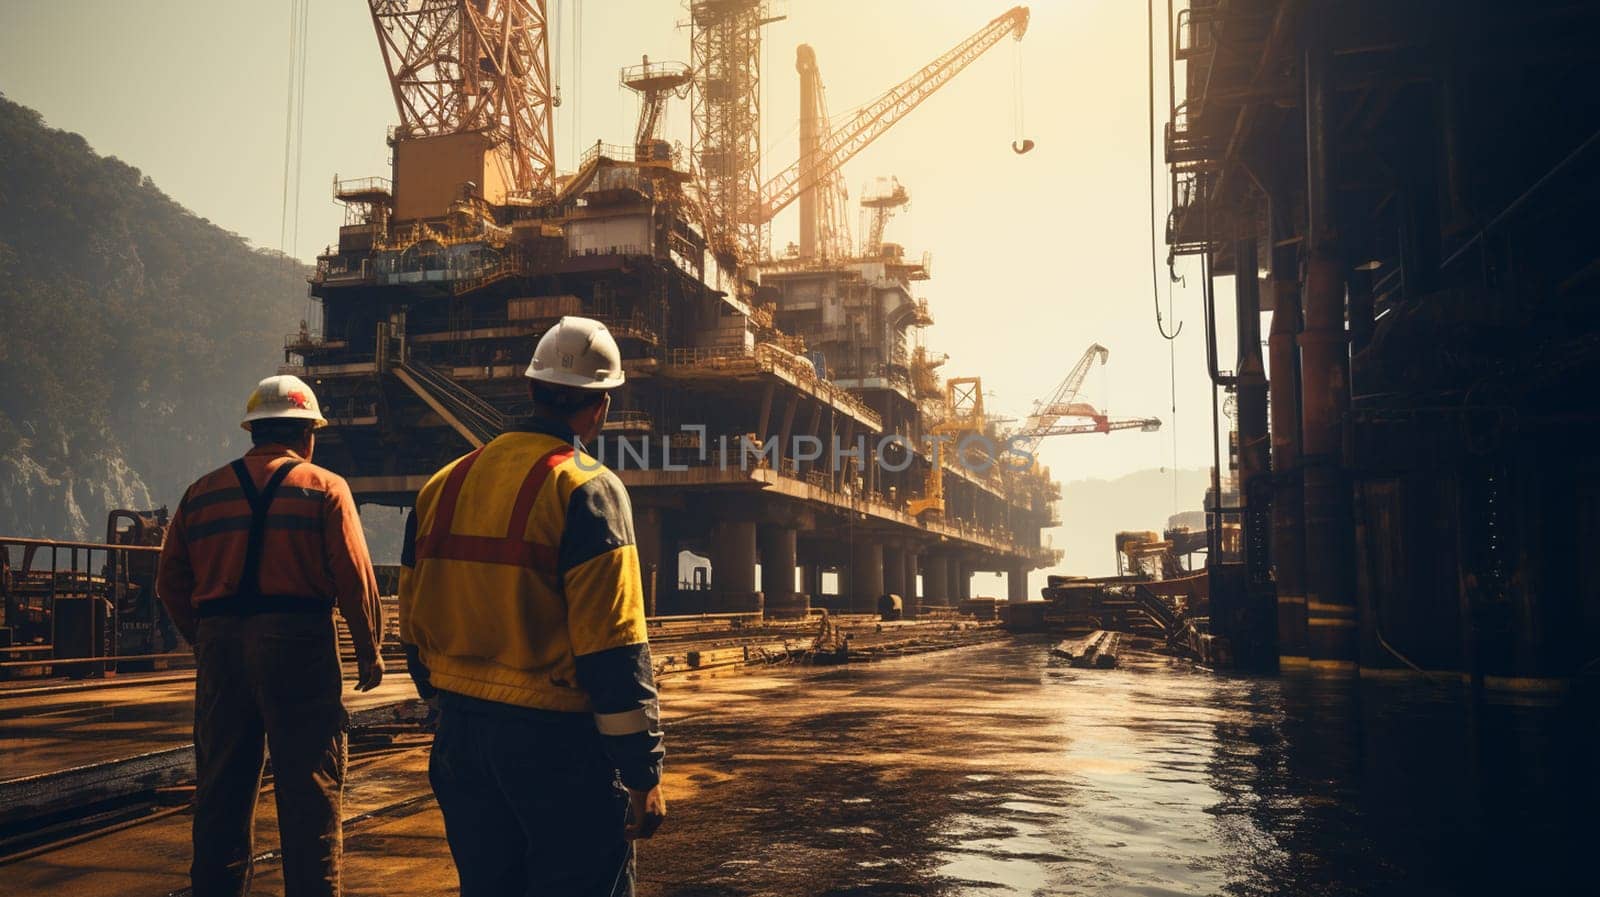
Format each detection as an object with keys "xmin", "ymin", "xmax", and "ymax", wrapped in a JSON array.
[{"xmin": 0, "ymin": 0, "xmax": 1234, "ymax": 563}]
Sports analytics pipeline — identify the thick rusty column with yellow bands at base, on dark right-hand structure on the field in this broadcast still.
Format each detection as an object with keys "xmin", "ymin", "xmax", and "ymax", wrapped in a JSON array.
[{"xmin": 1299, "ymin": 34, "xmax": 1358, "ymax": 670}]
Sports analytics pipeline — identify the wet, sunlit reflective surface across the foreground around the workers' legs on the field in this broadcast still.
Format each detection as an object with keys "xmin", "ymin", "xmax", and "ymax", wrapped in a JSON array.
[{"xmin": 0, "ymin": 643, "xmax": 1597, "ymax": 897}]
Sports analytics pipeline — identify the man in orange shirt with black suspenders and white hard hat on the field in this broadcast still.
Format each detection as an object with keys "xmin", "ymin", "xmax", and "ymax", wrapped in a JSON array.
[{"xmin": 157, "ymin": 376, "xmax": 384, "ymax": 897}]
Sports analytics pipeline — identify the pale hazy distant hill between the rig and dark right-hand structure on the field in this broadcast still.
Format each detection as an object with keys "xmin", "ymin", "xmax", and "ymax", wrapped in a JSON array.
[{"xmin": 1048, "ymin": 467, "xmax": 1211, "ymax": 576}]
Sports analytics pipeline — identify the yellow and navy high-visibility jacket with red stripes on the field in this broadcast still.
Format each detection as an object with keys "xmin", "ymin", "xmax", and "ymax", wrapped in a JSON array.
[{"xmin": 400, "ymin": 419, "xmax": 662, "ymax": 790}]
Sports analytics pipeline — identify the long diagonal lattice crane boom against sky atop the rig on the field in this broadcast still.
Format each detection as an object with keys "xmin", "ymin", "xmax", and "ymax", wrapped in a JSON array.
[{"xmin": 750, "ymin": 6, "xmax": 1029, "ymax": 225}]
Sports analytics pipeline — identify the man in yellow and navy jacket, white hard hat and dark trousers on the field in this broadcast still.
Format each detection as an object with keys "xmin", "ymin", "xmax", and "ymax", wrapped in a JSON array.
[{"xmin": 400, "ymin": 317, "xmax": 666, "ymax": 897}]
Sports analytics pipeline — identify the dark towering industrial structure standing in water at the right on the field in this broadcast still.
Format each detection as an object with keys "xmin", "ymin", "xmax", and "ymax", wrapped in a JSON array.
[{"xmin": 1165, "ymin": 0, "xmax": 1600, "ymax": 674}]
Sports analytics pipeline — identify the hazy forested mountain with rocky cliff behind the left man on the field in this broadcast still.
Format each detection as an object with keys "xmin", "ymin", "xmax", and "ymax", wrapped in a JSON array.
[{"xmin": 0, "ymin": 96, "xmax": 309, "ymax": 540}]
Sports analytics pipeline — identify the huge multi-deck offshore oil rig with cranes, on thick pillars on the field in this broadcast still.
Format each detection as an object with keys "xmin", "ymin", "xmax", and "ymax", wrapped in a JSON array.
[{"xmin": 285, "ymin": 0, "xmax": 1059, "ymax": 616}]
